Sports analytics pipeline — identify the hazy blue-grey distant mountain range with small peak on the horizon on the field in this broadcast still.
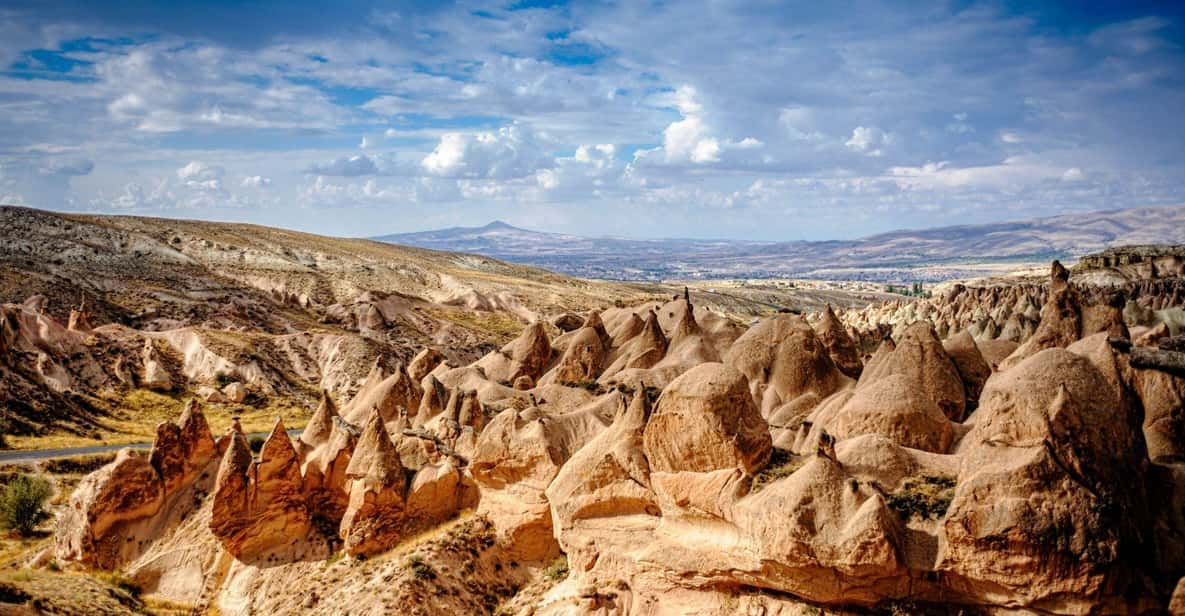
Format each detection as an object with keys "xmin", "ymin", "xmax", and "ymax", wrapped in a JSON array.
[{"xmin": 374, "ymin": 206, "xmax": 1185, "ymax": 281}]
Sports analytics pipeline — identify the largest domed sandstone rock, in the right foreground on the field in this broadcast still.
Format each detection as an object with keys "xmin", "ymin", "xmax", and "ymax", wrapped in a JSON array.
[{"xmin": 937, "ymin": 348, "xmax": 1148, "ymax": 612}]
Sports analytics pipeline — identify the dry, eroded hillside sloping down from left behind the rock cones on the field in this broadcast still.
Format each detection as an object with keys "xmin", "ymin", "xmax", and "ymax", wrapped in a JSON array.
[{"xmin": 0, "ymin": 207, "xmax": 875, "ymax": 448}]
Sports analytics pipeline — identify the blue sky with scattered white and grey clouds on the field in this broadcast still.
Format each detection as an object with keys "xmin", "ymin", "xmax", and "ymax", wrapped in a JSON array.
[{"xmin": 0, "ymin": 0, "xmax": 1185, "ymax": 240}]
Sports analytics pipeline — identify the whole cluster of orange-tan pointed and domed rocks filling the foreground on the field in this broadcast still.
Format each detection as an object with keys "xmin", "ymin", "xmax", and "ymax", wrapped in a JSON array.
[{"xmin": 48, "ymin": 277, "xmax": 1185, "ymax": 615}]
